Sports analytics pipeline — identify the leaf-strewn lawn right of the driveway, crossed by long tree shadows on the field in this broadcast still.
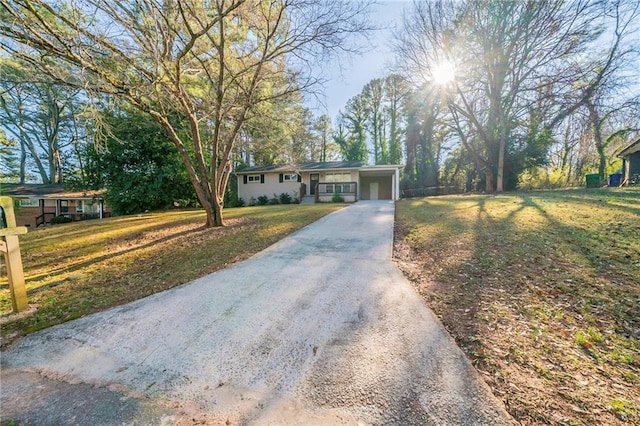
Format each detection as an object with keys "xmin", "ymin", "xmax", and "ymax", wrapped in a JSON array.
[{"xmin": 396, "ymin": 188, "xmax": 640, "ymax": 424}]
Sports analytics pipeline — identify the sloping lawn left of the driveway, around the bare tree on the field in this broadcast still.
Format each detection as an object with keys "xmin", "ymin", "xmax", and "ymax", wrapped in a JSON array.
[{"xmin": 0, "ymin": 204, "xmax": 340, "ymax": 344}]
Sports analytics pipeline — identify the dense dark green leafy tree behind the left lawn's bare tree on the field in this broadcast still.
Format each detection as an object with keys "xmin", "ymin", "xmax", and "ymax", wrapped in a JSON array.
[{"xmin": 86, "ymin": 108, "xmax": 197, "ymax": 214}]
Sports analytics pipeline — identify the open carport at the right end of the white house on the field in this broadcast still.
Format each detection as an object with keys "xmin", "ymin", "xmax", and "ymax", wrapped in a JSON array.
[{"xmin": 358, "ymin": 165, "xmax": 402, "ymax": 200}]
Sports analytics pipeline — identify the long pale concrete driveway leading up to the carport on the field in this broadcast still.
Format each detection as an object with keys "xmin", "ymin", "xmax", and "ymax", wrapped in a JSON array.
[{"xmin": 1, "ymin": 201, "xmax": 512, "ymax": 425}]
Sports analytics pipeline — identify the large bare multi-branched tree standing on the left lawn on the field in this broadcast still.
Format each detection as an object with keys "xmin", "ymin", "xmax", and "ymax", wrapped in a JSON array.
[{"xmin": 0, "ymin": 0, "xmax": 369, "ymax": 226}]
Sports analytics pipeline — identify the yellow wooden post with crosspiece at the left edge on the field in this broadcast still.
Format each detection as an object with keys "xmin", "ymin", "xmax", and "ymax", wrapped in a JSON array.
[{"xmin": 0, "ymin": 197, "xmax": 29, "ymax": 312}]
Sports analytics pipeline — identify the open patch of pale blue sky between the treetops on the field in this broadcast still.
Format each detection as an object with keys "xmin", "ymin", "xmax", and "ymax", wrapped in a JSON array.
[{"xmin": 308, "ymin": 0, "xmax": 412, "ymax": 121}]
